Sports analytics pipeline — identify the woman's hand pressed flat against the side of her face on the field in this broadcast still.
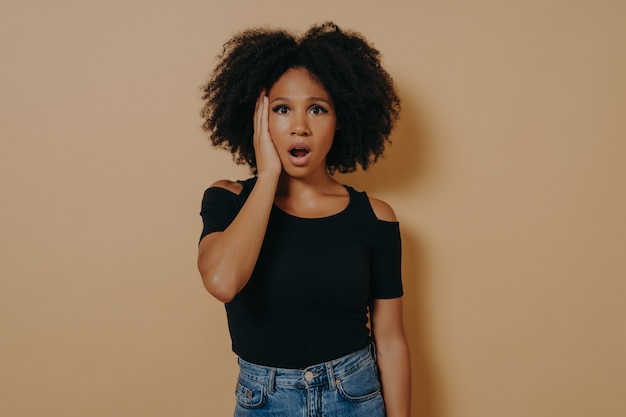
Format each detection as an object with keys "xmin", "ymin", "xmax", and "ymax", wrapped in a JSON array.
[{"xmin": 253, "ymin": 90, "xmax": 283, "ymax": 178}]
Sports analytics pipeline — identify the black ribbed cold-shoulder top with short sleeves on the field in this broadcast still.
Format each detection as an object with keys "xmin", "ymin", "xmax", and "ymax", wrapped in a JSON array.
[{"xmin": 200, "ymin": 178, "xmax": 402, "ymax": 369}]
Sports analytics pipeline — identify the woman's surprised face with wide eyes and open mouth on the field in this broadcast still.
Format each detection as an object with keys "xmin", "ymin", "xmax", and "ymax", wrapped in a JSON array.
[{"xmin": 268, "ymin": 68, "xmax": 337, "ymax": 177}]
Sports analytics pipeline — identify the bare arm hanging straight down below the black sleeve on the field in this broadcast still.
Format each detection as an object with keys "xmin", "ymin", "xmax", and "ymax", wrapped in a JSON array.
[{"xmin": 371, "ymin": 298, "xmax": 411, "ymax": 417}]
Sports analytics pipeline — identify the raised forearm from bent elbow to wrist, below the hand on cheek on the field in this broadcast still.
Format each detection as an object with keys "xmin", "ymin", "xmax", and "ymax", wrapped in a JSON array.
[{"xmin": 198, "ymin": 172, "xmax": 278, "ymax": 302}]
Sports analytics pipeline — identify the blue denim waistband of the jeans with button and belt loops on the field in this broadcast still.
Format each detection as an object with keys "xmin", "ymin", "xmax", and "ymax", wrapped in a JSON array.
[{"xmin": 238, "ymin": 343, "xmax": 376, "ymax": 394}]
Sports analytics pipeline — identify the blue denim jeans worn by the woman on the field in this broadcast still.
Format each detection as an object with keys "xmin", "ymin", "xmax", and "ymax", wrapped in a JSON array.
[{"xmin": 235, "ymin": 346, "xmax": 385, "ymax": 417}]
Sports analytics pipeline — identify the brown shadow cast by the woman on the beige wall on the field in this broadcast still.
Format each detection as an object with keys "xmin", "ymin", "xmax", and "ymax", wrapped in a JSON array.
[{"xmin": 336, "ymin": 97, "xmax": 441, "ymax": 417}]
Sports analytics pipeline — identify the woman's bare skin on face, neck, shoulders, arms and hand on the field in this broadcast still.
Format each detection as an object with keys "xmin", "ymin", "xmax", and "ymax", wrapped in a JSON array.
[{"xmin": 198, "ymin": 68, "xmax": 411, "ymax": 417}]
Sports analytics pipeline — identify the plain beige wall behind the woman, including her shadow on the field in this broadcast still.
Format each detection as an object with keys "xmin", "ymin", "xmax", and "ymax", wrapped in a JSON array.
[{"xmin": 0, "ymin": 0, "xmax": 626, "ymax": 417}]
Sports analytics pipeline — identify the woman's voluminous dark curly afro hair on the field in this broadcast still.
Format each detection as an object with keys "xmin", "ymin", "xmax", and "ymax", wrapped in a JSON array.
[{"xmin": 201, "ymin": 22, "xmax": 400, "ymax": 174}]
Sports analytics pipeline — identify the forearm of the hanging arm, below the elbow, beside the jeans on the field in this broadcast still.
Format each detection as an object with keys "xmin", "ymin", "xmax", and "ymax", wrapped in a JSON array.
[{"xmin": 377, "ymin": 340, "xmax": 411, "ymax": 417}]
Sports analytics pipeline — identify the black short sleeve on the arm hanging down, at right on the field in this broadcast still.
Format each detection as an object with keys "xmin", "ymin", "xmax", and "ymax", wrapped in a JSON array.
[{"xmin": 370, "ymin": 220, "xmax": 403, "ymax": 299}]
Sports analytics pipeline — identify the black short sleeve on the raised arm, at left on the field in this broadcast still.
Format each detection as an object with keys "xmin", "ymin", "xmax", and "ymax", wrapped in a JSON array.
[{"xmin": 200, "ymin": 187, "xmax": 239, "ymax": 240}]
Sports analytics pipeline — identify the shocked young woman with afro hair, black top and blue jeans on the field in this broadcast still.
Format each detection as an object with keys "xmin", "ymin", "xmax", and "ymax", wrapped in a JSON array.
[{"xmin": 198, "ymin": 23, "xmax": 410, "ymax": 417}]
